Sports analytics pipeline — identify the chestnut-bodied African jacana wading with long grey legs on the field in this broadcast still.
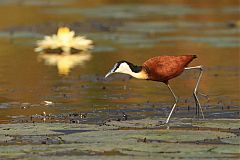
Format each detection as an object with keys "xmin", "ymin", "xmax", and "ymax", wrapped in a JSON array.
[{"xmin": 105, "ymin": 55, "xmax": 204, "ymax": 123}]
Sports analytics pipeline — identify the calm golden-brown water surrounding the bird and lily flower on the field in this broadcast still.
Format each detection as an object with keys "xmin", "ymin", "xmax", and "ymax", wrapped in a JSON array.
[{"xmin": 0, "ymin": 0, "xmax": 240, "ymax": 123}]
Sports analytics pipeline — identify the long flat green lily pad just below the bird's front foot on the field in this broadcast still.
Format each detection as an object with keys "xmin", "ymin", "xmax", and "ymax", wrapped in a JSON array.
[{"xmin": 62, "ymin": 130, "xmax": 234, "ymax": 145}]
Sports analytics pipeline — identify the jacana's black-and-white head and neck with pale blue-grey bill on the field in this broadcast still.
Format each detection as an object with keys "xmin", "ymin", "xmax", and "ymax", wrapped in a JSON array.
[{"xmin": 105, "ymin": 61, "xmax": 147, "ymax": 79}]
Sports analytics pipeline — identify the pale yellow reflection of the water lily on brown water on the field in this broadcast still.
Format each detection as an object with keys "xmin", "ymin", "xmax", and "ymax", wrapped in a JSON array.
[{"xmin": 38, "ymin": 51, "xmax": 92, "ymax": 75}]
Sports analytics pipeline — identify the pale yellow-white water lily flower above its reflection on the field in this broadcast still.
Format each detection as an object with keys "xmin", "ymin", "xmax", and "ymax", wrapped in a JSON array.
[{"xmin": 35, "ymin": 27, "xmax": 93, "ymax": 53}]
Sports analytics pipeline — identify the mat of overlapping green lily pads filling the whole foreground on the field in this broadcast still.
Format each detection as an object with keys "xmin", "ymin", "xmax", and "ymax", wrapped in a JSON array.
[{"xmin": 0, "ymin": 119, "xmax": 240, "ymax": 160}]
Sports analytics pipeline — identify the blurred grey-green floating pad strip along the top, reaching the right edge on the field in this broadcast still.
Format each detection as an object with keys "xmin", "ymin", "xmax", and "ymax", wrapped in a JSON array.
[{"xmin": 44, "ymin": 3, "xmax": 239, "ymax": 19}]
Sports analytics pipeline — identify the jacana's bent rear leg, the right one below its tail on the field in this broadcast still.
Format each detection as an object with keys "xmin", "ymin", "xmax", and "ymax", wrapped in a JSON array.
[{"xmin": 185, "ymin": 66, "xmax": 204, "ymax": 119}]
